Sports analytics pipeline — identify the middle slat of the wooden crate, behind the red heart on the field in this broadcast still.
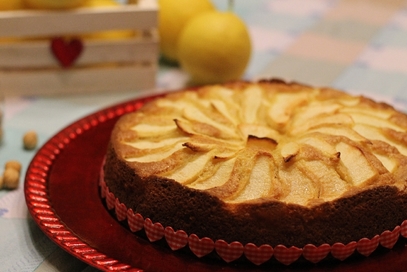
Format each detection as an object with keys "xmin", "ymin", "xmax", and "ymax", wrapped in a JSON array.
[{"xmin": 0, "ymin": 31, "xmax": 159, "ymax": 70}]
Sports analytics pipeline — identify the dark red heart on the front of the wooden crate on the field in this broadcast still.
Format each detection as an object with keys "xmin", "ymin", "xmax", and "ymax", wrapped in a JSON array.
[{"xmin": 51, "ymin": 37, "xmax": 83, "ymax": 67}]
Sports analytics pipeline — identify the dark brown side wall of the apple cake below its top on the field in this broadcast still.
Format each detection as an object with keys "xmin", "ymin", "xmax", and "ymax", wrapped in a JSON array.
[{"xmin": 105, "ymin": 146, "xmax": 407, "ymax": 247}]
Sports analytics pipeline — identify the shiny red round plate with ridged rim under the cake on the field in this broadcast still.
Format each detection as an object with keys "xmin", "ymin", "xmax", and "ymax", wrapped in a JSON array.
[{"xmin": 24, "ymin": 94, "xmax": 407, "ymax": 272}]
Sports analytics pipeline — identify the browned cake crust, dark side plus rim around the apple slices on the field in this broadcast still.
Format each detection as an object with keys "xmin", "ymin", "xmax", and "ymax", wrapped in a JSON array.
[{"xmin": 104, "ymin": 81, "xmax": 407, "ymax": 247}]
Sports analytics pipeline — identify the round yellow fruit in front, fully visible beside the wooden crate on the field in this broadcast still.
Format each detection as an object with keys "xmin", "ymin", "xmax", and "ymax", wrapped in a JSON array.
[{"xmin": 178, "ymin": 11, "xmax": 251, "ymax": 84}]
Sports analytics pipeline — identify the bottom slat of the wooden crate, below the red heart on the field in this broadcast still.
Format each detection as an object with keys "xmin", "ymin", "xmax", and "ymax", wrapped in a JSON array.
[{"xmin": 0, "ymin": 65, "xmax": 157, "ymax": 95}]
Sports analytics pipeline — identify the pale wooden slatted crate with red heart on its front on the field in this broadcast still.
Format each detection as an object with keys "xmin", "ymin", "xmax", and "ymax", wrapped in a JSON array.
[{"xmin": 0, "ymin": 0, "xmax": 159, "ymax": 95}]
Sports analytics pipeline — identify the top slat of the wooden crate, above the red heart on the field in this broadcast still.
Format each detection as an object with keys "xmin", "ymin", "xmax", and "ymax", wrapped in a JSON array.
[{"xmin": 0, "ymin": 0, "xmax": 157, "ymax": 37}]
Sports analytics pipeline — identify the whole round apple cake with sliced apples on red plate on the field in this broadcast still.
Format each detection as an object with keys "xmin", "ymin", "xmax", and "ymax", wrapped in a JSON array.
[{"xmin": 103, "ymin": 79, "xmax": 407, "ymax": 255}]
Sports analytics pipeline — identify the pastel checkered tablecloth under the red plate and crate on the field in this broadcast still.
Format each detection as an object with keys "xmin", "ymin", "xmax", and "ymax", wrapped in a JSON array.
[{"xmin": 0, "ymin": 0, "xmax": 407, "ymax": 272}]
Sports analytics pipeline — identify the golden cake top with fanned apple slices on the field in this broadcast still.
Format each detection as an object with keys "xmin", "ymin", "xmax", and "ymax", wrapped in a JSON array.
[{"xmin": 113, "ymin": 81, "xmax": 407, "ymax": 206}]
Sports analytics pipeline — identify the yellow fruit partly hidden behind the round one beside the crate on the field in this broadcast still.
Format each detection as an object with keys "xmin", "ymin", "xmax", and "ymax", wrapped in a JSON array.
[{"xmin": 158, "ymin": 0, "xmax": 215, "ymax": 62}]
